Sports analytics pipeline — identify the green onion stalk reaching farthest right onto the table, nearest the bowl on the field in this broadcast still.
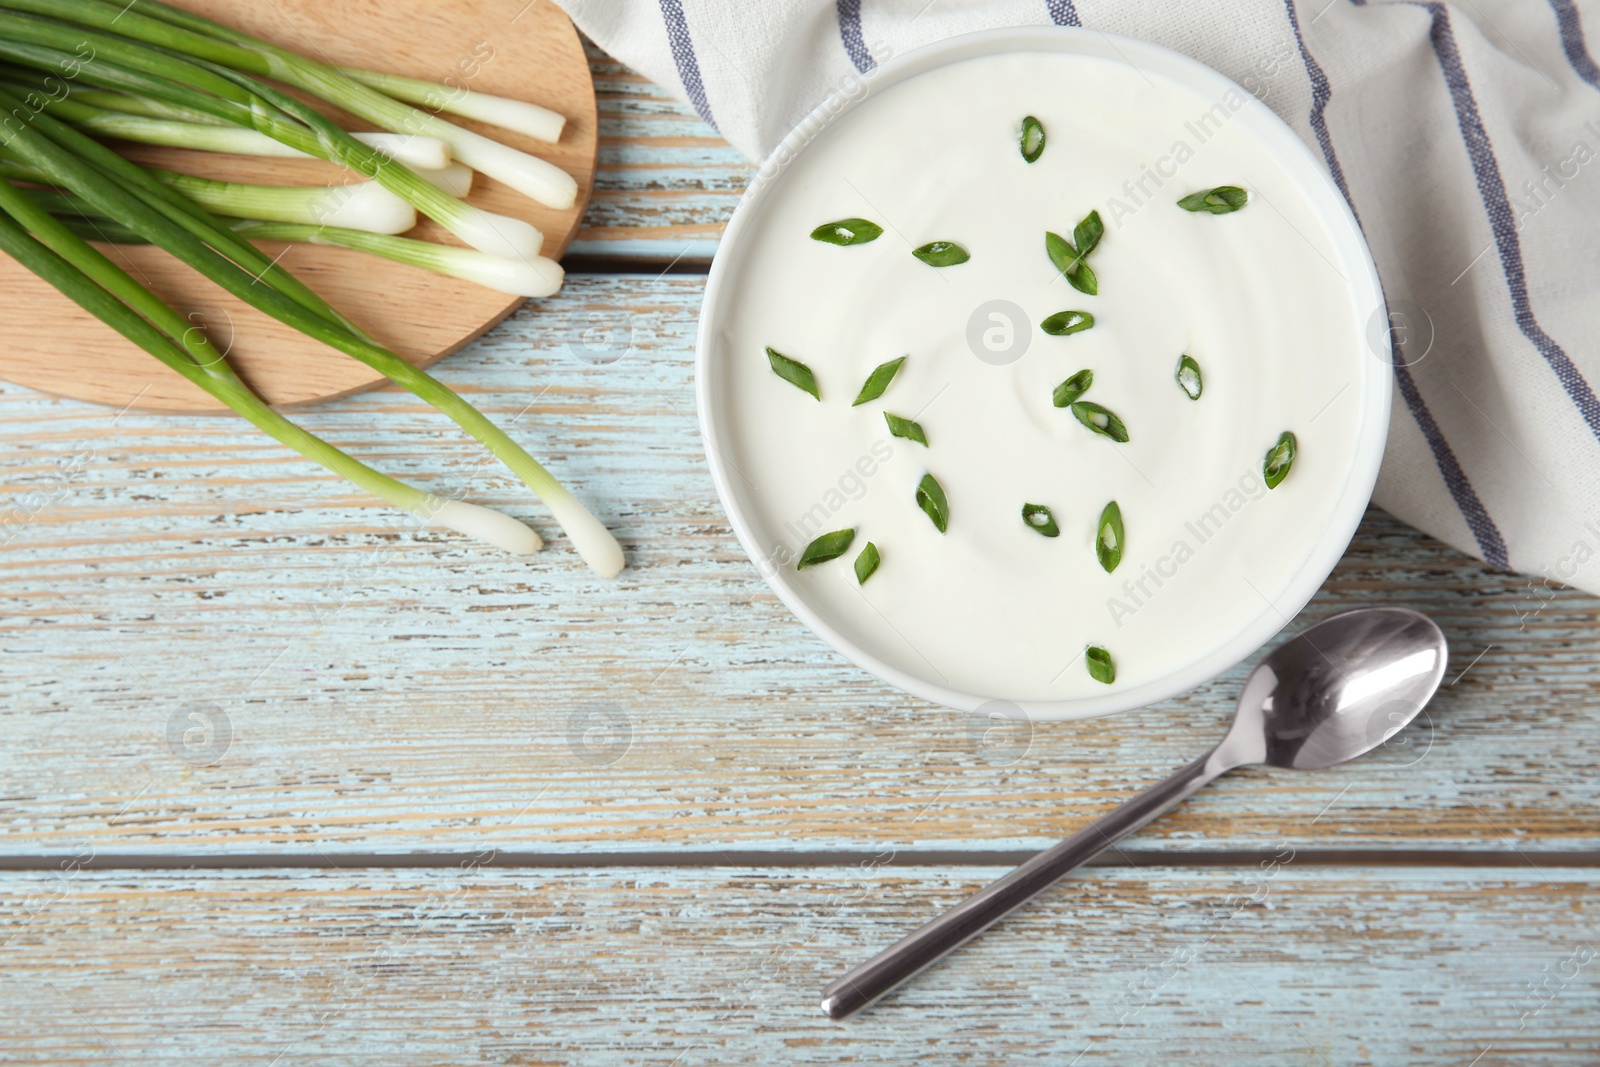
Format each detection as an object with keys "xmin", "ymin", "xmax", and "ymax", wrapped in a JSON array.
[{"xmin": 0, "ymin": 90, "xmax": 624, "ymax": 577}]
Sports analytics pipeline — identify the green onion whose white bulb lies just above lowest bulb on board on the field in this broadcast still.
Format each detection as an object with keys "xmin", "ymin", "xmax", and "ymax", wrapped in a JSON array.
[{"xmin": 0, "ymin": 17, "xmax": 544, "ymax": 259}]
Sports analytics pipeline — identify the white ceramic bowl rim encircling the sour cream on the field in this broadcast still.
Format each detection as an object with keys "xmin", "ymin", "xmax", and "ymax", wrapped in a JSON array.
[{"xmin": 696, "ymin": 27, "xmax": 1394, "ymax": 718}]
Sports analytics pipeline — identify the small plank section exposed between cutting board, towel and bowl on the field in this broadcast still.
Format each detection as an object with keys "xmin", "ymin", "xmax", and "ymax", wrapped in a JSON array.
[{"xmin": 568, "ymin": 45, "xmax": 755, "ymax": 269}]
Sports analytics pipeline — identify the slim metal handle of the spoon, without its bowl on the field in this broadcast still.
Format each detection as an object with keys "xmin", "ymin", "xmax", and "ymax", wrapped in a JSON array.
[{"xmin": 822, "ymin": 753, "xmax": 1227, "ymax": 1019}]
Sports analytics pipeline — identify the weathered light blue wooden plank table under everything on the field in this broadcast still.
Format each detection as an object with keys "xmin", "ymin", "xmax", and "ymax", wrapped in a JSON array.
[{"xmin": 0, "ymin": 37, "xmax": 1600, "ymax": 1067}]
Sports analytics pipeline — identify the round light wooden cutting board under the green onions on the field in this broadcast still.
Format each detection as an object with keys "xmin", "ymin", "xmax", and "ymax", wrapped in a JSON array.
[{"xmin": 0, "ymin": 0, "xmax": 597, "ymax": 413}]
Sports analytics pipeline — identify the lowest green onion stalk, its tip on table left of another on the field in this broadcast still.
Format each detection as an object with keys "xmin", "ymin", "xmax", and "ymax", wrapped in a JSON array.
[{"xmin": 0, "ymin": 182, "xmax": 542, "ymax": 555}]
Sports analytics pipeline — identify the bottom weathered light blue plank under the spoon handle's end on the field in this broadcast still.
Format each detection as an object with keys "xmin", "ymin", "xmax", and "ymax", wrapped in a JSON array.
[{"xmin": 0, "ymin": 870, "xmax": 1600, "ymax": 1067}]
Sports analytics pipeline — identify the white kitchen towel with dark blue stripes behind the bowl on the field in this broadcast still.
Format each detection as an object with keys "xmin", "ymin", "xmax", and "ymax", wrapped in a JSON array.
[{"xmin": 558, "ymin": 0, "xmax": 1600, "ymax": 592}]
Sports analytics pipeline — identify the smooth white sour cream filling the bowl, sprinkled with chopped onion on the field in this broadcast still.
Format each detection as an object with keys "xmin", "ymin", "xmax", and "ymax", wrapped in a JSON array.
[{"xmin": 714, "ymin": 51, "xmax": 1381, "ymax": 702}]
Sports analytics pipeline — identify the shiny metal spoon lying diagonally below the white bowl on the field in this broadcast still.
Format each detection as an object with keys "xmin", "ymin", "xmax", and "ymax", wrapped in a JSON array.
[{"xmin": 822, "ymin": 608, "xmax": 1450, "ymax": 1019}]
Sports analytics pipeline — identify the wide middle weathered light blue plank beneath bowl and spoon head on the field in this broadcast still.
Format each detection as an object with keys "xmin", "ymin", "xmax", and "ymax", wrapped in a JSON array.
[{"xmin": 0, "ymin": 275, "xmax": 1600, "ymax": 856}]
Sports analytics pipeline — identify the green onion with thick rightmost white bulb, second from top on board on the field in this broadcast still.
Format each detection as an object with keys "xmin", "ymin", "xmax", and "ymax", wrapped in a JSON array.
[{"xmin": 0, "ymin": 0, "xmax": 578, "ymax": 211}]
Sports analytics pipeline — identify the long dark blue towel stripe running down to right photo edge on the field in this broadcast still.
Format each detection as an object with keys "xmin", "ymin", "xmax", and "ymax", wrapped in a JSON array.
[{"xmin": 1416, "ymin": 3, "xmax": 1600, "ymax": 438}]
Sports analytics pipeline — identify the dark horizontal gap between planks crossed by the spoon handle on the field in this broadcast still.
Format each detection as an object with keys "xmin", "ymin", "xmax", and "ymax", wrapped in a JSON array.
[{"xmin": 0, "ymin": 846, "xmax": 1600, "ymax": 872}]
